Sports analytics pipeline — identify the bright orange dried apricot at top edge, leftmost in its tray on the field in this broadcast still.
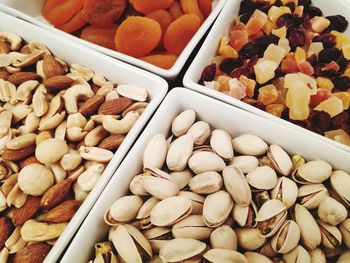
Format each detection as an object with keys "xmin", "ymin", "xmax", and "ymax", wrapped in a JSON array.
[{"xmin": 41, "ymin": 0, "xmax": 84, "ymax": 26}]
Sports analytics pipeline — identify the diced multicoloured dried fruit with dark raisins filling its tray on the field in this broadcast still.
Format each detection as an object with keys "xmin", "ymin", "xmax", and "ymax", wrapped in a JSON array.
[{"xmin": 199, "ymin": 0, "xmax": 350, "ymax": 146}]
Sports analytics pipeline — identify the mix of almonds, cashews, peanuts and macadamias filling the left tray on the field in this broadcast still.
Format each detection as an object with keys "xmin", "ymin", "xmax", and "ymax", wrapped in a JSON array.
[{"xmin": 0, "ymin": 32, "xmax": 148, "ymax": 262}]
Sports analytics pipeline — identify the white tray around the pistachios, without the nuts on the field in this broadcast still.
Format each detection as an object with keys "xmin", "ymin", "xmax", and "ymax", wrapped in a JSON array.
[{"xmin": 61, "ymin": 88, "xmax": 350, "ymax": 263}]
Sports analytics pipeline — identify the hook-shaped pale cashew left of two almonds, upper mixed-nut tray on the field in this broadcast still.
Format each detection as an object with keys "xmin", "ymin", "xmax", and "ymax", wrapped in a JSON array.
[{"xmin": 63, "ymin": 85, "xmax": 95, "ymax": 114}]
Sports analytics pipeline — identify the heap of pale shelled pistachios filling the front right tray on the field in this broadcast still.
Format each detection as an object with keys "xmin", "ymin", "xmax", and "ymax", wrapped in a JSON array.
[{"xmin": 87, "ymin": 110, "xmax": 350, "ymax": 263}]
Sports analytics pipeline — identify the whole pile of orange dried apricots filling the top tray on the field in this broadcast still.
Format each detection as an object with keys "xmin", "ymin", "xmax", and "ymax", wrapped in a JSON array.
[{"xmin": 42, "ymin": 0, "xmax": 215, "ymax": 69}]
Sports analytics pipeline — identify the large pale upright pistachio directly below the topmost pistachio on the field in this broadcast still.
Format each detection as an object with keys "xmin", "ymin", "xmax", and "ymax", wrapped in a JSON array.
[{"xmin": 166, "ymin": 134, "xmax": 193, "ymax": 172}]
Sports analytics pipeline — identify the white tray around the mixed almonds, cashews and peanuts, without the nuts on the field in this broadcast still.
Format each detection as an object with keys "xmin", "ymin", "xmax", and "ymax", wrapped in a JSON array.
[{"xmin": 0, "ymin": 12, "xmax": 168, "ymax": 263}]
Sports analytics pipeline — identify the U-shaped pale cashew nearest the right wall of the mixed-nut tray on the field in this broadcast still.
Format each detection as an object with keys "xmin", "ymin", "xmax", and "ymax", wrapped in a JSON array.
[{"xmin": 102, "ymin": 111, "xmax": 140, "ymax": 134}]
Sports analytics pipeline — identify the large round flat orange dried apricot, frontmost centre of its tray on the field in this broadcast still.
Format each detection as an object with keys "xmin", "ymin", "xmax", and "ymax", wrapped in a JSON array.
[{"xmin": 114, "ymin": 16, "xmax": 162, "ymax": 57}]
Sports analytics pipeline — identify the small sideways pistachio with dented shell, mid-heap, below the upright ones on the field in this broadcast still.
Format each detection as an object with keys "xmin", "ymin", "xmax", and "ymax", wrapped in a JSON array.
[{"xmin": 188, "ymin": 172, "xmax": 223, "ymax": 194}]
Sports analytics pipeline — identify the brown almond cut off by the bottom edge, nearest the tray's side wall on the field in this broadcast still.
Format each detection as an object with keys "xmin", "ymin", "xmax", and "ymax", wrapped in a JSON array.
[{"xmin": 12, "ymin": 242, "xmax": 51, "ymax": 263}]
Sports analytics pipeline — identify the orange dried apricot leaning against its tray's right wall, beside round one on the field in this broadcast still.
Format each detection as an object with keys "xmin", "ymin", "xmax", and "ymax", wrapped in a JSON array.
[{"xmin": 164, "ymin": 14, "xmax": 201, "ymax": 55}]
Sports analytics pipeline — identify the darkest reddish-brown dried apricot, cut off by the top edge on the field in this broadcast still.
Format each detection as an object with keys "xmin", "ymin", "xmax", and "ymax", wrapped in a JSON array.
[{"xmin": 83, "ymin": 0, "xmax": 127, "ymax": 26}]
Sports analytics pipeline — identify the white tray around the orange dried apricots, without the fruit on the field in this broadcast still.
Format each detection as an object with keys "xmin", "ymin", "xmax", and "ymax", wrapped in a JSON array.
[{"xmin": 0, "ymin": 0, "xmax": 226, "ymax": 79}]
